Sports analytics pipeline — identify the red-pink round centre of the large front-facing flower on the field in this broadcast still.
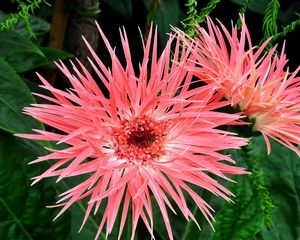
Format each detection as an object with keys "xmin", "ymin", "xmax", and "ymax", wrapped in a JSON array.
[{"xmin": 111, "ymin": 115, "xmax": 167, "ymax": 162}]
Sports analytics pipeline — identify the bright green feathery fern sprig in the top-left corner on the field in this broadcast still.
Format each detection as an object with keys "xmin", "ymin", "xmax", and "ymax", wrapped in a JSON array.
[{"xmin": 0, "ymin": 0, "xmax": 49, "ymax": 38}]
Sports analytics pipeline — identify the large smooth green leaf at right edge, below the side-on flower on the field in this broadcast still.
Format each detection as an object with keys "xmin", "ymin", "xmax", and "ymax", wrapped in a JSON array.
[{"xmin": 256, "ymin": 138, "xmax": 300, "ymax": 240}]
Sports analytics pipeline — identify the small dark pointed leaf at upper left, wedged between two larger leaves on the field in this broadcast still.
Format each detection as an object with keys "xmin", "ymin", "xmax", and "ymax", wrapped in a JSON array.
[{"xmin": 5, "ymin": 47, "xmax": 73, "ymax": 73}]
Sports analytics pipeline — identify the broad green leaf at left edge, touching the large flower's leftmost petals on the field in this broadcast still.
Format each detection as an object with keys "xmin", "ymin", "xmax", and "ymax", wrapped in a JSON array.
[{"xmin": 0, "ymin": 58, "xmax": 43, "ymax": 133}]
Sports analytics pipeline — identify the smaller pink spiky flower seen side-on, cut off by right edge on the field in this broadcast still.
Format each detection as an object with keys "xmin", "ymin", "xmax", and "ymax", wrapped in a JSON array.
[{"xmin": 183, "ymin": 18, "xmax": 300, "ymax": 155}]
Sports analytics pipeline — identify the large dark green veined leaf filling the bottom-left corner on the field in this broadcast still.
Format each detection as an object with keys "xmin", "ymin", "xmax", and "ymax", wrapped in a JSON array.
[{"xmin": 0, "ymin": 131, "xmax": 70, "ymax": 240}]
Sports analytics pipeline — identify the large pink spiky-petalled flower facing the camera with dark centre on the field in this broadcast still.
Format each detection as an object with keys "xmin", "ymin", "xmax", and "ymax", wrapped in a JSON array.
[{"xmin": 19, "ymin": 24, "xmax": 247, "ymax": 239}]
